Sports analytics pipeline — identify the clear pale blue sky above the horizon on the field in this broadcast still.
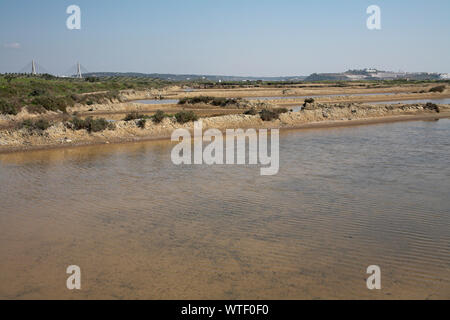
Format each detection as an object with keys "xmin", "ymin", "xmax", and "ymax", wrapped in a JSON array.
[{"xmin": 0, "ymin": 0, "xmax": 450, "ymax": 76}]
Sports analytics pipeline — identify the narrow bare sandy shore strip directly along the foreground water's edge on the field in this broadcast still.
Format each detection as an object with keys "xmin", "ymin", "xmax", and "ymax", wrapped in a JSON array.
[{"xmin": 0, "ymin": 106, "xmax": 450, "ymax": 154}]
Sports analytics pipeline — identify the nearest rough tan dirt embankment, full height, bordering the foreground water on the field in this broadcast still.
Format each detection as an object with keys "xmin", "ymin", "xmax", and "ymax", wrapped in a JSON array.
[{"xmin": 0, "ymin": 103, "xmax": 450, "ymax": 152}]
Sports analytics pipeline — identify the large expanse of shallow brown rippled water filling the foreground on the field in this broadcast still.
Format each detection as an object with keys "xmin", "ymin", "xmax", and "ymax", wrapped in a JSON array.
[{"xmin": 0, "ymin": 120, "xmax": 450, "ymax": 299}]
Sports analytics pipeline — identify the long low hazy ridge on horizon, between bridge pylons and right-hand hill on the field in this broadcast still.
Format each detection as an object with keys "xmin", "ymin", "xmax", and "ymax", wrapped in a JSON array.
[{"xmin": 83, "ymin": 72, "xmax": 306, "ymax": 81}]
